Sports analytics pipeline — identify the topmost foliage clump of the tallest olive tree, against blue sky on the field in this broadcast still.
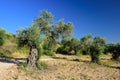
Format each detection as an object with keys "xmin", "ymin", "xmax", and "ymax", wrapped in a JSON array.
[{"xmin": 34, "ymin": 11, "xmax": 53, "ymax": 36}]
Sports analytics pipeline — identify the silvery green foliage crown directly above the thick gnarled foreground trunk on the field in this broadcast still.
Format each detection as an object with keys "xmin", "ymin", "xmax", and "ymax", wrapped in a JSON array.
[{"xmin": 17, "ymin": 26, "xmax": 40, "ymax": 47}]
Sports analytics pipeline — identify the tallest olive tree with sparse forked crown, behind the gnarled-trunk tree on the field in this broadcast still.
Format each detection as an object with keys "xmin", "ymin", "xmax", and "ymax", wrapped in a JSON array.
[{"xmin": 34, "ymin": 11, "xmax": 73, "ymax": 51}]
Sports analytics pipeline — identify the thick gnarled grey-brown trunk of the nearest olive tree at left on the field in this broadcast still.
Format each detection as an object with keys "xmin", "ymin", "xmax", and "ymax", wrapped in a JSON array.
[{"xmin": 27, "ymin": 46, "xmax": 38, "ymax": 70}]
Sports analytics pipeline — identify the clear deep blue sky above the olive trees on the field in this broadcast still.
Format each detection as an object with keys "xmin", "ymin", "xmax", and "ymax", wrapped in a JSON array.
[{"xmin": 0, "ymin": 0, "xmax": 120, "ymax": 42}]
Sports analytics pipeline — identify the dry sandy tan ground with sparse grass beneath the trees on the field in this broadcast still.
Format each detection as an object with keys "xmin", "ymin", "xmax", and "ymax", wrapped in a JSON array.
[{"xmin": 0, "ymin": 54, "xmax": 120, "ymax": 80}]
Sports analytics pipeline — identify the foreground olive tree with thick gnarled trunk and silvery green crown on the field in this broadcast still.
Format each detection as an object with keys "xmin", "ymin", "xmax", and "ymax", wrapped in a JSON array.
[{"xmin": 17, "ymin": 26, "xmax": 41, "ymax": 70}]
